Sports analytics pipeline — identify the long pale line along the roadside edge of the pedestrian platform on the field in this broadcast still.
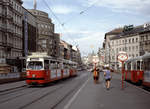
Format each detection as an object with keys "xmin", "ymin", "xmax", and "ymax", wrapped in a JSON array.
[{"xmin": 64, "ymin": 78, "xmax": 90, "ymax": 109}]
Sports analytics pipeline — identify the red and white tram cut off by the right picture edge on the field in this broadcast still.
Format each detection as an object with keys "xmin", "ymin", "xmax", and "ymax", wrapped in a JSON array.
[{"xmin": 125, "ymin": 53, "xmax": 150, "ymax": 87}]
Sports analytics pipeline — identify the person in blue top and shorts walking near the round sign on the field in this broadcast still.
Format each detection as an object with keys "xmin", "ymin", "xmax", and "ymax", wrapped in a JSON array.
[{"xmin": 104, "ymin": 67, "xmax": 112, "ymax": 90}]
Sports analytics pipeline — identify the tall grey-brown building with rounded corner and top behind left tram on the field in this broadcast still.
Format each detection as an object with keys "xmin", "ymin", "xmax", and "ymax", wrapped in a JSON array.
[{"xmin": 28, "ymin": 9, "xmax": 55, "ymax": 56}]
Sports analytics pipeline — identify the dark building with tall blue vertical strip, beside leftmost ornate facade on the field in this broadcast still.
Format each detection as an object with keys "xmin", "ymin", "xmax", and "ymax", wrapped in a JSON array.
[{"xmin": 22, "ymin": 8, "xmax": 38, "ymax": 56}]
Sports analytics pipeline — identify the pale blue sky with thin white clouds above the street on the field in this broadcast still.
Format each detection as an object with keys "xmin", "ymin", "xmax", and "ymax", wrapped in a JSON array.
[{"xmin": 22, "ymin": 0, "xmax": 150, "ymax": 56}]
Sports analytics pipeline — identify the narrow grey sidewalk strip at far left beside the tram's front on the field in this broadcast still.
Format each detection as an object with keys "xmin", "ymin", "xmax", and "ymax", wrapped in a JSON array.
[{"xmin": 0, "ymin": 81, "xmax": 26, "ymax": 92}]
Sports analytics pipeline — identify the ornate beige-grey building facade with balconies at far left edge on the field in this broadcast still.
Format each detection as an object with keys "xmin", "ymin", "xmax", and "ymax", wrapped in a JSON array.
[{"xmin": 0, "ymin": 0, "xmax": 23, "ymax": 59}]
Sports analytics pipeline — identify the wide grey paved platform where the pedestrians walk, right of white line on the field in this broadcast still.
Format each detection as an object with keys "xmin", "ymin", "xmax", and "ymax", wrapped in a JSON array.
[{"xmin": 64, "ymin": 74, "xmax": 150, "ymax": 109}]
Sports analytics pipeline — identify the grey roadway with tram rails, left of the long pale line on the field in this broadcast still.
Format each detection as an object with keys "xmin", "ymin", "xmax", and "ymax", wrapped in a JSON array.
[{"xmin": 0, "ymin": 72, "xmax": 89, "ymax": 109}]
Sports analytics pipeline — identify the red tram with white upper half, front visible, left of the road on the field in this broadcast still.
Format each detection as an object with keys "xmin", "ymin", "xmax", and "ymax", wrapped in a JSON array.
[{"xmin": 26, "ymin": 53, "xmax": 77, "ymax": 84}]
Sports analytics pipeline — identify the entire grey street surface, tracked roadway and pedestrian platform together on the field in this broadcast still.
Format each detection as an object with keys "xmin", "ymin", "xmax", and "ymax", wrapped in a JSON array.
[{"xmin": 0, "ymin": 71, "xmax": 150, "ymax": 109}]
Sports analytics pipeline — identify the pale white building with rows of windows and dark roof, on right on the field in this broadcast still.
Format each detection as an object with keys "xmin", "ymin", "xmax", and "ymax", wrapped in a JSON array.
[{"xmin": 109, "ymin": 26, "xmax": 143, "ymax": 69}]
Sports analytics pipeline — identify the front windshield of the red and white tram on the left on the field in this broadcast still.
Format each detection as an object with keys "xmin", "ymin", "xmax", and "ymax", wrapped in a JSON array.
[{"xmin": 27, "ymin": 61, "xmax": 43, "ymax": 70}]
